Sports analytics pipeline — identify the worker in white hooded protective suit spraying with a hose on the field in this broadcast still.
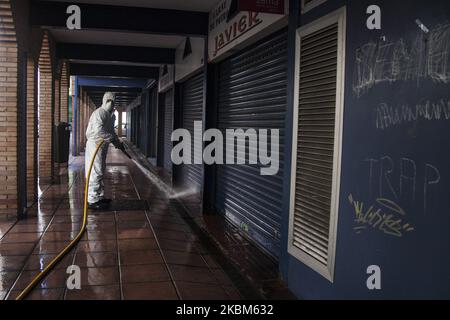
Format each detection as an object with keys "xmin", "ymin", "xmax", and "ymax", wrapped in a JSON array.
[{"xmin": 85, "ymin": 92, "xmax": 124, "ymax": 210}]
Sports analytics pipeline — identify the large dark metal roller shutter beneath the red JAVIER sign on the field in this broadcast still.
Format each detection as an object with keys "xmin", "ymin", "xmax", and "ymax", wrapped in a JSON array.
[{"xmin": 216, "ymin": 32, "xmax": 287, "ymax": 257}]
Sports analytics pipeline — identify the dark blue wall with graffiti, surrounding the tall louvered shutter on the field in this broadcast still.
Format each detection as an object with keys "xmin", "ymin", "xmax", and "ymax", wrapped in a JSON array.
[{"xmin": 280, "ymin": 0, "xmax": 450, "ymax": 299}]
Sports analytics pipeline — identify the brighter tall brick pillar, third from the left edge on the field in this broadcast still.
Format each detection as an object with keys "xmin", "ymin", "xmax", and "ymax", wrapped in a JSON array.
[{"xmin": 39, "ymin": 33, "xmax": 54, "ymax": 183}]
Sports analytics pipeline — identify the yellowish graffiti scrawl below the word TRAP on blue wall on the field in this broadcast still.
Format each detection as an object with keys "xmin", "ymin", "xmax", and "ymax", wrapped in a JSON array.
[{"xmin": 348, "ymin": 194, "xmax": 414, "ymax": 237}]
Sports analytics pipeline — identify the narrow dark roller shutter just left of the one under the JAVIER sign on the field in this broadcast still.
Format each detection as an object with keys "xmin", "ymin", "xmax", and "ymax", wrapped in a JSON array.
[{"xmin": 180, "ymin": 72, "xmax": 203, "ymax": 192}]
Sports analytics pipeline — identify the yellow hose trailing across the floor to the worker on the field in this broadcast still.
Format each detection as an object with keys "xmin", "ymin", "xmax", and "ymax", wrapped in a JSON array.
[{"xmin": 16, "ymin": 140, "xmax": 105, "ymax": 300}]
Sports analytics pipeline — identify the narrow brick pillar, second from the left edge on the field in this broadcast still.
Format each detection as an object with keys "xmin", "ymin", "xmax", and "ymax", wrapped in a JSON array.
[{"xmin": 27, "ymin": 57, "xmax": 37, "ymax": 204}]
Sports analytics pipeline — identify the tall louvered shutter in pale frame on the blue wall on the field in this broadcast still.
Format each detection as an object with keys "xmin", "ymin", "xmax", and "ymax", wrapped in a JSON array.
[{"xmin": 289, "ymin": 8, "xmax": 344, "ymax": 282}]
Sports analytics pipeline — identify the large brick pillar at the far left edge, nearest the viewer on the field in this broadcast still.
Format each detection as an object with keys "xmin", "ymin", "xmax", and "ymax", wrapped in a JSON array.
[{"xmin": 0, "ymin": 0, "xmax": 19, "ymax": 218}]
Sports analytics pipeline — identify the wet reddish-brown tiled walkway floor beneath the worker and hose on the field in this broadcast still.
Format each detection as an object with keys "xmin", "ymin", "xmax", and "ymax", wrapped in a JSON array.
[{"xmin": 0, "ymin": 149, "xmax": 243, "ymax": 300}]
